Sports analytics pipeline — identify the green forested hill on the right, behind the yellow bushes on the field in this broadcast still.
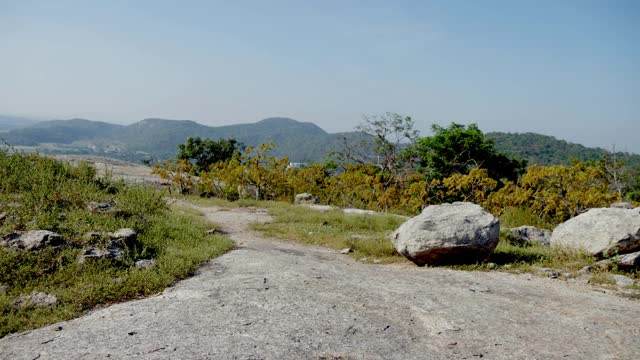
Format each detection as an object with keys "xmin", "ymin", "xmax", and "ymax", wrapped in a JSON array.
[{"xmin": 485, "ymin": 132, "xmax": 640, "ymax": 167}]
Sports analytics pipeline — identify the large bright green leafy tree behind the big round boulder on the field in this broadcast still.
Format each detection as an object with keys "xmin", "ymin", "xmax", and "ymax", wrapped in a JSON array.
[{"xmin": 413, "ymin": 123, "xmax": 526, "ymax": 181}]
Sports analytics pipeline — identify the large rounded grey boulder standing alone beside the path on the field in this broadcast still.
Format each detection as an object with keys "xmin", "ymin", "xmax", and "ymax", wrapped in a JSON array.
[{"xmin": 391, "ymin": 202, "xmax": 500, "ymax": 266}]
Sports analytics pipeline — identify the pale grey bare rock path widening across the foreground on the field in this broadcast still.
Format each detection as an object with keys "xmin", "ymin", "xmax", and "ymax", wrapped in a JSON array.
[{"xmin": 0, "ymin": 204, "xmax": 640, "ymax": 360}]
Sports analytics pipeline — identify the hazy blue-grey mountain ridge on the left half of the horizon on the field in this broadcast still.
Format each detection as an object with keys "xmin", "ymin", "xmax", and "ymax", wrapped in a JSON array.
[{"xmin": 0, "ymin": 118, "xmax": 362, "ymax": 162}]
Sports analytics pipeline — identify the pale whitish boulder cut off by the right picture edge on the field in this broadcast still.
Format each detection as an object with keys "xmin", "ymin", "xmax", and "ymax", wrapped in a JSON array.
[{"xmin": 551, "ymin": 208, "xmax": 640, "ymax": 258}]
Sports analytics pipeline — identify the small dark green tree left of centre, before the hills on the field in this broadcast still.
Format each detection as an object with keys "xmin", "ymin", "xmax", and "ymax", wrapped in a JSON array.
[{"xmin": 177, "ymin": 136, "xmax": 242, "ymax": 173}]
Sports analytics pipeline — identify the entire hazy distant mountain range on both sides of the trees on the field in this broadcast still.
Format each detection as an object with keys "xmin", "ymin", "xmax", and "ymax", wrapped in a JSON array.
[{"xmin": 0, "ymin": 116, "xmax": 640, "ymax": 167}]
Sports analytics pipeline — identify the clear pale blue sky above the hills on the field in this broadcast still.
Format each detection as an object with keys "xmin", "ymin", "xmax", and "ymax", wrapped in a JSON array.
[{"xmin": 0, "ymin": 0, "xmax": 640, "ymax": 153}]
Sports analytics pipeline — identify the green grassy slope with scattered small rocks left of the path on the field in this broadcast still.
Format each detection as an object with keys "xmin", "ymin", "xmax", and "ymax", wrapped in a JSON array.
[{"xmin": 0, "ymin": 151, "xmax": 232, "ymax": 336}]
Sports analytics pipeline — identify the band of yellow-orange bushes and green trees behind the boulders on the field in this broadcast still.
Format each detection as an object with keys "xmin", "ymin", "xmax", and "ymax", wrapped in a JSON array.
[{"xmin": 154, "ymin": 118, "xmax": 638, "ymax": 218}]
